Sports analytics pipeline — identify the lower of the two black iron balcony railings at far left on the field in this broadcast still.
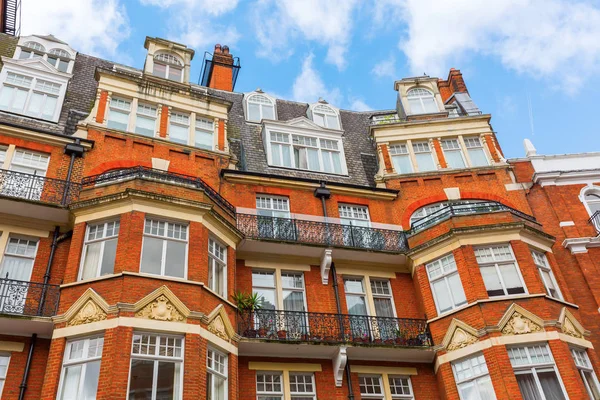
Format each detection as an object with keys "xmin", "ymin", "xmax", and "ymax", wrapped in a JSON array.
[{"xmin": 0, "ymin": 278, "xmax": 60, "ymax": 317}]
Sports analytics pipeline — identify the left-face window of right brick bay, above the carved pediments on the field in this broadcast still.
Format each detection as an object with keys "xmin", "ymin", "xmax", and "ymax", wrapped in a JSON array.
[{"xmin": 426, "ymin": 254, "xmax": 467, "ymax": 314}]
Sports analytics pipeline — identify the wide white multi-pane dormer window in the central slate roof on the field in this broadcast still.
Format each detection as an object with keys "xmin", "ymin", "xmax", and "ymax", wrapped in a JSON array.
[{"xmin": 267, "ymin": 132, "xmax": 345, "ymax": 174}]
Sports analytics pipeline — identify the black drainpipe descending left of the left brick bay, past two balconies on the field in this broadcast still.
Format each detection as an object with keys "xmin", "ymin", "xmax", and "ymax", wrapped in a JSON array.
[{"xmin": 19, "ymin": 138, "xmax": 85, "ymax": 400}]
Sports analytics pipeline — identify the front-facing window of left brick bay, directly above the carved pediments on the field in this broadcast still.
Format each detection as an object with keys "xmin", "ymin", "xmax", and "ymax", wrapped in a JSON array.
[{"xmin": 140, "ymin": 218, "xmax": 188, "ymax": 278}]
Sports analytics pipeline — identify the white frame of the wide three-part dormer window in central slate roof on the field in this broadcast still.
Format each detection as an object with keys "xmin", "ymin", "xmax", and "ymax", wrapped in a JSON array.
[{"xmin": 263, "ymin": 125, "xmax": 348, "ymax": 176}]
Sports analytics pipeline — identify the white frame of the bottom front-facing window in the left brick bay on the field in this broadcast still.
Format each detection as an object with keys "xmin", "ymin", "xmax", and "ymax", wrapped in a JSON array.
[{"xmin": 127, "ymin": 332, "xmax": 185, "ymax": 400}]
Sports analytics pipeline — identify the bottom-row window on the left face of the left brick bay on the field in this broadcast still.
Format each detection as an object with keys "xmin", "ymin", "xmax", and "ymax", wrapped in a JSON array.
[{"xmin": 58, "ymin": 337, "xmax": 104, "ymax": 400}]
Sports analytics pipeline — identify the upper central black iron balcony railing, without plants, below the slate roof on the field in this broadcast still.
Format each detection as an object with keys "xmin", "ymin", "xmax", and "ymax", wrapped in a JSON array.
[{"xmin": 237, "ymin": 214, "xmax": 408, "ymax": 252}]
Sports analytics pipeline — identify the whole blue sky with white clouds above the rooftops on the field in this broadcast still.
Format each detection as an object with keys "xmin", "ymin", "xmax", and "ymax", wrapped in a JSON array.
[{"xmin": 22, "ymin": 0, "xmax": 600, "ymax": 157}]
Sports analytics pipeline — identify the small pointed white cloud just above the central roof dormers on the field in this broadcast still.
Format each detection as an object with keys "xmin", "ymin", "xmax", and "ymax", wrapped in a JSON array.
[{"xmin": 292, "ymin": 54, "xmax": 341, "ymax": 105}]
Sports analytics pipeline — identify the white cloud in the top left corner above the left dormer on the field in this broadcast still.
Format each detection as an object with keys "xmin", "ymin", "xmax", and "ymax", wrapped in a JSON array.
[{"xmin": 21, "ymin": 0, "xmax": 130, "ymax": 60}]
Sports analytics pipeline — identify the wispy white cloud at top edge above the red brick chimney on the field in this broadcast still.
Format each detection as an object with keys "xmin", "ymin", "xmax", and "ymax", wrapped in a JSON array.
[{"xmin": 140, "ymin": 0, "xmax": 240, "ymax": 50}]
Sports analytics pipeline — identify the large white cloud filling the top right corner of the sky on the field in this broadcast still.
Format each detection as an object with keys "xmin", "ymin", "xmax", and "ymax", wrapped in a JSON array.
[{"xmin": 399, "ymin": 0, "xmax": 600, "ymax": 93}]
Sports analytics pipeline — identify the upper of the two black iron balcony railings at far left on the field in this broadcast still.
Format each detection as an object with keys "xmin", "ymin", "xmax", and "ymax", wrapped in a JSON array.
[{"xmin": 0, "ymin": 169, "xmax": 81, "ymax": 206}]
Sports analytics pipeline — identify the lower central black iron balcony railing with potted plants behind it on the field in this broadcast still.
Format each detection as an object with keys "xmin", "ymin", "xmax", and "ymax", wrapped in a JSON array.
[{"xmin": 238, "ymin": 309, "xmax": 433, "ymax": 347}]
